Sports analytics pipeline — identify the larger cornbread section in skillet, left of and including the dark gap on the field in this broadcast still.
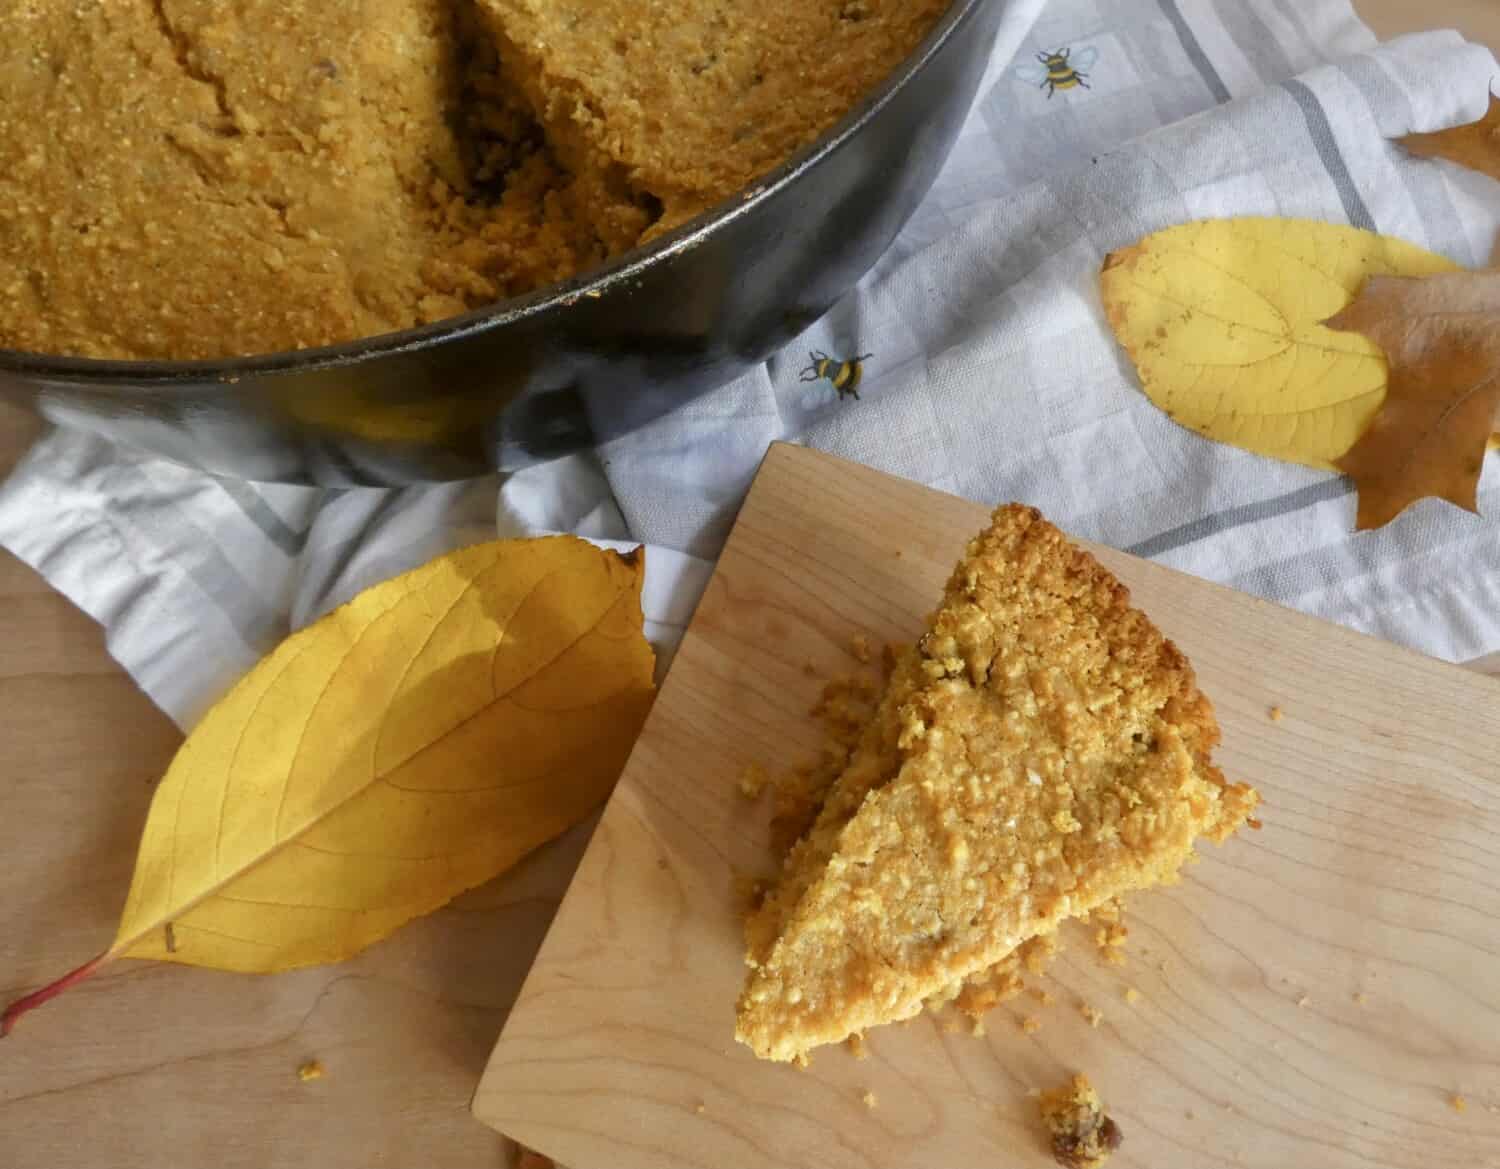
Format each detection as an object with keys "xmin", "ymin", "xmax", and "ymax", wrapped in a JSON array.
[{"xmin": 0, "ymin": 0, "xmax": 608, "ymax": 359}]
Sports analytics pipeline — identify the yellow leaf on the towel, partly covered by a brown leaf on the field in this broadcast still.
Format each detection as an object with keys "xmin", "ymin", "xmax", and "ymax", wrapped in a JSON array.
[{"xmin": 1101, "ymin": 219, "xmax": 1457, "ymax": 468}]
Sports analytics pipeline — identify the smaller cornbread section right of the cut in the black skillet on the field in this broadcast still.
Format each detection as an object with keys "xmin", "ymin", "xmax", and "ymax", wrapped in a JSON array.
[{"xmin": 480, "ymin": 0, "xmax": 950, "ymax": 237}]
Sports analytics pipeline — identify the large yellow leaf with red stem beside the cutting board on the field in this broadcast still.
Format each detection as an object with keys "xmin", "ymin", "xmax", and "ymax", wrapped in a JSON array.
[{"xmin": 5, "ymin": 537, "xmax": 653, "ymax": 1029}]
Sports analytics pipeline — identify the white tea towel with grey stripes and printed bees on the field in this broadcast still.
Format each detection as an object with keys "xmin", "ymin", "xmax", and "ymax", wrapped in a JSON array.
[{"xmin": 0, "ymin": 0, "xmax": 1500, "ymax": 725}]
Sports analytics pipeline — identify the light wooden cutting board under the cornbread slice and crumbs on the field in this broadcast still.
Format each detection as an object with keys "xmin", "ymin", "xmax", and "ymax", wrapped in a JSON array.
[{"xmin": 474, "ymin": 446, "xmax": 1500, "ymax": 1169}]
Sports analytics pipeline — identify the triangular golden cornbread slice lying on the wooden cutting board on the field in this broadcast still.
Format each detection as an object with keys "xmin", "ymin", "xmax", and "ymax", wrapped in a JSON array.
[{"xmin": 737, "ymin": 506, "xmax": 1257, "ymax": 1059}]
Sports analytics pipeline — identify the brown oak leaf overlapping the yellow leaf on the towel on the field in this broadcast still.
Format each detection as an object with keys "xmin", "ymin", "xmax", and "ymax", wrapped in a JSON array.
[{"xmin": 1328, "ymin": 272, "xmax": 1500, "ymax": 531}]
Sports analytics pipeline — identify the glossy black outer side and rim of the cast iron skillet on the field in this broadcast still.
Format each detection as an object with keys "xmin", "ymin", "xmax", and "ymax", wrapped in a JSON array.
[{"xmin": 0, "ymin": 0, "xmax": 1007, "ymax": 485}]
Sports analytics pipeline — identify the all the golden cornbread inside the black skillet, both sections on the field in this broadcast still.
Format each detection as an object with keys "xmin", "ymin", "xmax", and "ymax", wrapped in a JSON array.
[{"xmin": 0, "ymin": 0, "xmax": 947, "ymax": 359}]
